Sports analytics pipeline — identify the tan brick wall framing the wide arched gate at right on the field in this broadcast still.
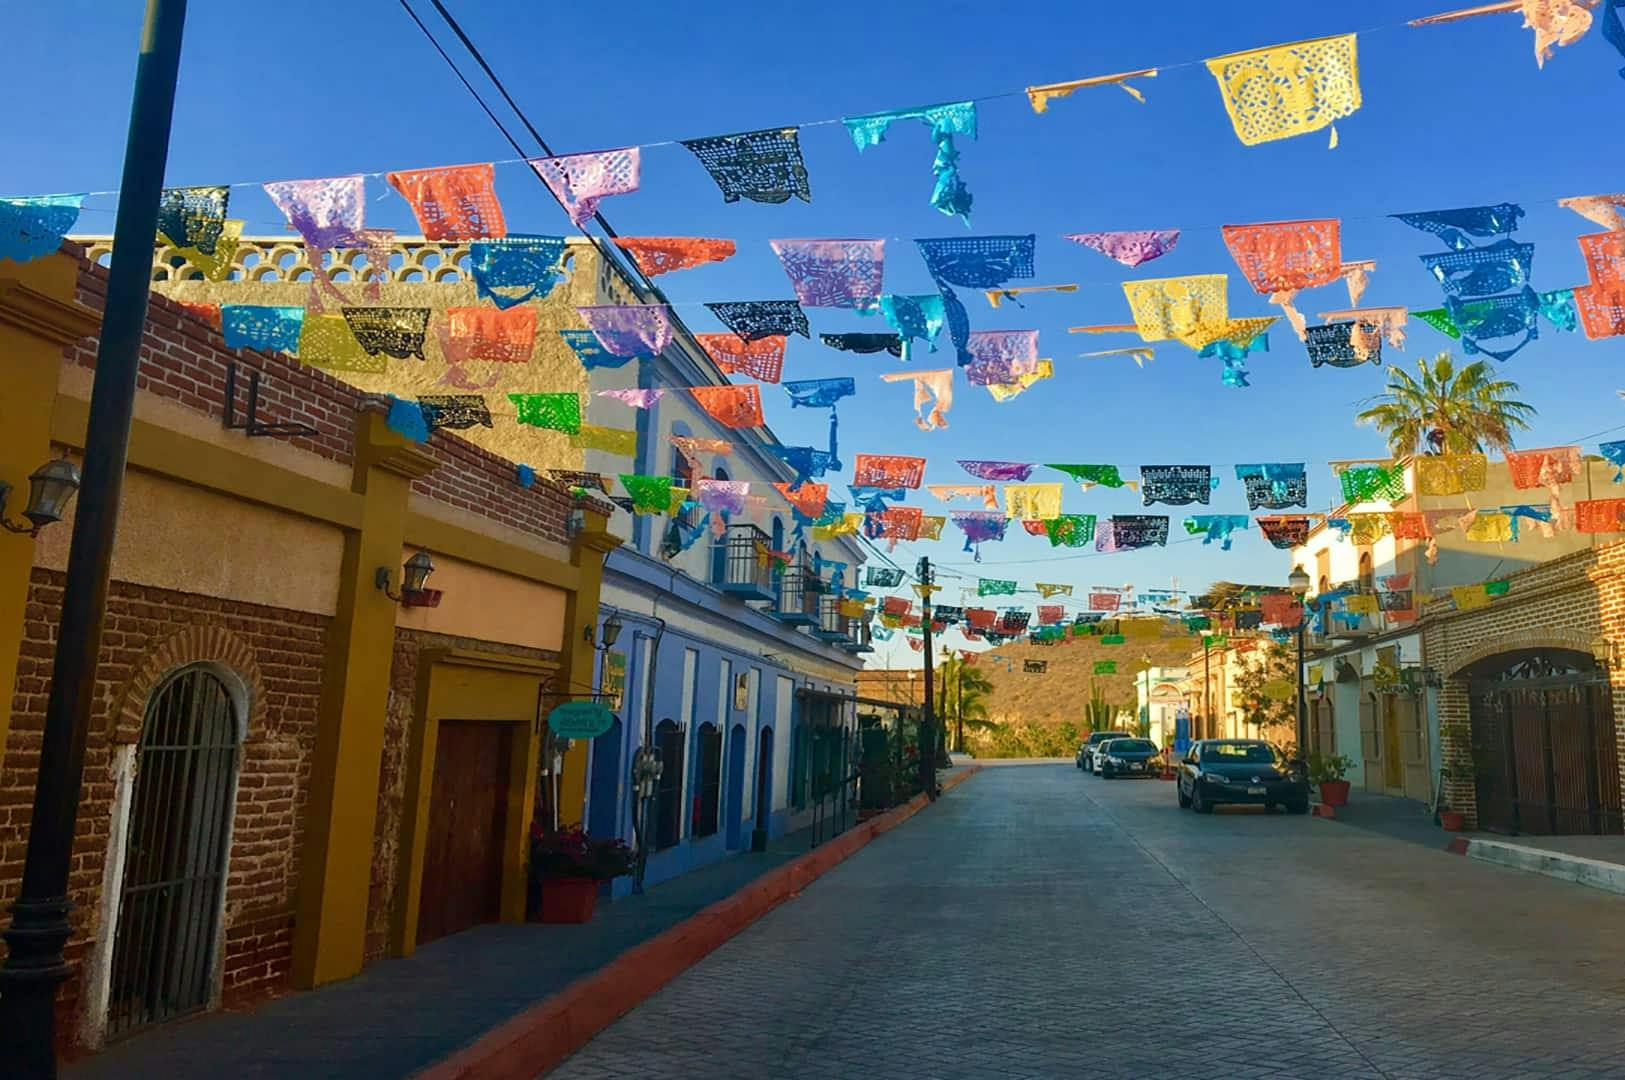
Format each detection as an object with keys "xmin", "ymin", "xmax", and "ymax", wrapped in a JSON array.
[{"xmin": 1422, "ymin": 541, "xmax": 1625, "ymax": 828}]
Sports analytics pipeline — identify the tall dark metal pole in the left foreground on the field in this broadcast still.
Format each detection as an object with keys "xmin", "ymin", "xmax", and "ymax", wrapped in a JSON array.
[{"xmin": 0, "ymin": 0, "xmax": 187, "ymax": 1080}]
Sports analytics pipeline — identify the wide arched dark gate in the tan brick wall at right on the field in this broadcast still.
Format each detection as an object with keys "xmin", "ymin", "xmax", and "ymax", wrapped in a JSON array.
[{"xmin": 1464, "ymin": 648, "xmax": 1622, "ymax": 833}]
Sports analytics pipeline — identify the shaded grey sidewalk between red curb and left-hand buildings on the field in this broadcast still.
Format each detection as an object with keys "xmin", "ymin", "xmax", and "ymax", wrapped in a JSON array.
[{"xmin": 63, "ymin": 812, "xmax": 864, "ymax": 1080}]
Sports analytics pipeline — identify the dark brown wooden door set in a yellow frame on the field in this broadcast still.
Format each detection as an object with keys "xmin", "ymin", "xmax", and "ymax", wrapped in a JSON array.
[{"xmin": 418, "ymin": 719, "xmax": 514, "ymax": 945}]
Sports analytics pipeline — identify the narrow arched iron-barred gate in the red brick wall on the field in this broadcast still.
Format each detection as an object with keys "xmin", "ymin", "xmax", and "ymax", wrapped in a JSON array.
[{"xmin": 107, "ymin": 667, "xmax": 237, "ymax": 1038}]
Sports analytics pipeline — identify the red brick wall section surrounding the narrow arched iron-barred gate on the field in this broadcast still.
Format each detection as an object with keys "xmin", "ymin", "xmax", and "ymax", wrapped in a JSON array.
[{"xmin": 0, "ymin": 568, "xmax": 328, "ymax": 1039}]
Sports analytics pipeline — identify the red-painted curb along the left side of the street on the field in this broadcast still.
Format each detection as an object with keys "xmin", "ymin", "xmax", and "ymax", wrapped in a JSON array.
[{"xmin": 416, "ymin": 765, "xmax": 982, "ymax": 1080}]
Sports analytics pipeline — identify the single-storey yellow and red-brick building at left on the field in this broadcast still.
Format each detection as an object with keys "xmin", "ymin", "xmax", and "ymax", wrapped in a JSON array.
[{"xmin": 0, "ymin": 244, "xmax": 619, "ymax": 1048}]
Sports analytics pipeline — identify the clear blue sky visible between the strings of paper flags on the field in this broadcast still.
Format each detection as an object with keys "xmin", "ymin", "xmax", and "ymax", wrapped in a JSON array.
[{"xmin": 9, "ymin": 0, "xmax": 1625, "ymax": 665}]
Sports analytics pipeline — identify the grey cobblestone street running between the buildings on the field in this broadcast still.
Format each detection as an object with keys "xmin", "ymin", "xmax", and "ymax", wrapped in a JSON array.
[{"xmin": 551, "ymin": 765, "xmax": 1625, "ymax": 1080}]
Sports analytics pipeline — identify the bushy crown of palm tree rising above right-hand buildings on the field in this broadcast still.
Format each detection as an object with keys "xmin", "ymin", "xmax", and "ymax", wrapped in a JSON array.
[{"xmin": 1354, "ymin": 352, "xmax": 1536, "ymax": 458}]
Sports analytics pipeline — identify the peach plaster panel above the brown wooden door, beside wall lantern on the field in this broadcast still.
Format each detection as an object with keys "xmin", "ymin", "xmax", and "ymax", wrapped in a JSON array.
[{"xmin": 392, "ymin": 546, "xmax": 569, "ymax": 651}]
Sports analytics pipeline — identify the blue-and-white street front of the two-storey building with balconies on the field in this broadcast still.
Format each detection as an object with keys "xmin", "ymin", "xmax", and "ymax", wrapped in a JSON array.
[{"xmin": 583, "ymin": 248, "xmax": 869, "ymax": 888}]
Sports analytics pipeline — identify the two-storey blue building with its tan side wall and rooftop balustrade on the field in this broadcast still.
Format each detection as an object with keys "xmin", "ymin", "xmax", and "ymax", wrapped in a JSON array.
[{"xmin": 88, "ymin": 235, "xmax": 868, "ymax": 892}]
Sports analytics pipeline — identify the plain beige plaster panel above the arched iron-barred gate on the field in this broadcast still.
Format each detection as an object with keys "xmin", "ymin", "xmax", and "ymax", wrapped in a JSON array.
[{"xmin": 34, "ymin": 469, "xmax": 345, "ymax": 616}]
